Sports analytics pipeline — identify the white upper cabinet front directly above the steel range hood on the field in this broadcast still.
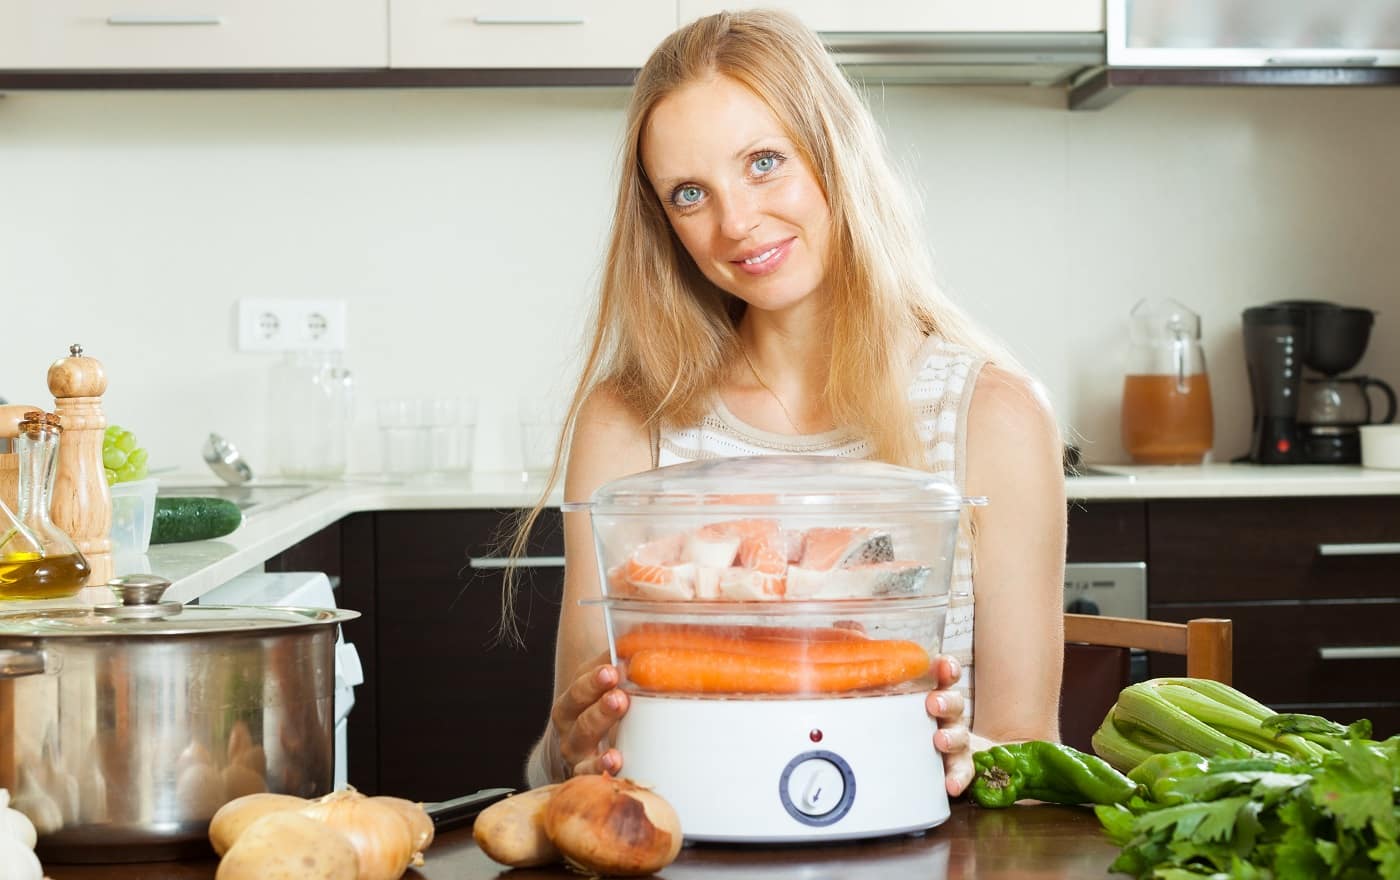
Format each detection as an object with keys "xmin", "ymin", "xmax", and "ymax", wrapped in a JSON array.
[{"xmin": 679, "ymin": 0, "xmax": 1103, "ymax": 34}]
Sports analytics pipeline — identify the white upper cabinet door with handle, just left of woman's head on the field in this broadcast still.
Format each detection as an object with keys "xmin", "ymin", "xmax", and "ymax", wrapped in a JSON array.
[{"xmin": 389, "ymin": 0, "xmax": 676, "ymax": 67}]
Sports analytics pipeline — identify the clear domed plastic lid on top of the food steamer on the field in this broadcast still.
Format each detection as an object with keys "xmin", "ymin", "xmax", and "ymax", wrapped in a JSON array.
[{"xmin": 564, "ymin": 455, "xmax": 986, "ymax": 513}]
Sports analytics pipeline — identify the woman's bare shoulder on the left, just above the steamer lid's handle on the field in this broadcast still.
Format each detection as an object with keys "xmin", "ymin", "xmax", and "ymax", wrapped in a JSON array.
[{"xmin": 564, "ymin": 385, "xmax": 651, "ymax": 501}]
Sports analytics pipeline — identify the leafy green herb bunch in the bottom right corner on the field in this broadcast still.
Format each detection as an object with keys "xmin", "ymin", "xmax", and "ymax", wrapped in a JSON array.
[{"xmin": 1095, "ymin": 715, "xmax": 1400, "ymax": 880}]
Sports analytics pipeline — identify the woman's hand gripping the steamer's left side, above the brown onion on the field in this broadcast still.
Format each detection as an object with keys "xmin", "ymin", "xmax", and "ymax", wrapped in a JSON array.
[{"xmin": 550, "ymin": 652, "xmax": 627, "ymax": 776}]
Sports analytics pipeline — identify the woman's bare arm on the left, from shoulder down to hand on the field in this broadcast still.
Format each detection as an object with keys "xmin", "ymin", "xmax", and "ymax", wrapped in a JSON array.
[{"xmin": 526, "ymin": 389, "xmax": 651, "ymax": 786}]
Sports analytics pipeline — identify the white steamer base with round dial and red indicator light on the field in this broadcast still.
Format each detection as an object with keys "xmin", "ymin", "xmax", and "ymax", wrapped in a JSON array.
[{"xmin": 616, "ymin": 693, "xmax": 948, "ymax": 844}]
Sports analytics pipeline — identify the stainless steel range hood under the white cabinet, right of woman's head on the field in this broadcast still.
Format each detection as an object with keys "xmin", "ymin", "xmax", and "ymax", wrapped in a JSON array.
[{"xmin": 822, "ymin": 31, "xmax": 1106, "ymax": 85}]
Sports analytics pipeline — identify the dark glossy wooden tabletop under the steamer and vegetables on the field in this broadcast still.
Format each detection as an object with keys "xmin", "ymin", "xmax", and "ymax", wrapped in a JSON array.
[{"xmin": 45, "ymin": 802, "xmax": 1117, "ymax": 880}]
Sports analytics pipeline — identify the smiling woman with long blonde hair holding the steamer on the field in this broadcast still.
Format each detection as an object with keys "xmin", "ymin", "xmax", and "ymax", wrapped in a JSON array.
[{"xmin": 522, "ymin": 11, "xmax": 1065, "ymax": 795}]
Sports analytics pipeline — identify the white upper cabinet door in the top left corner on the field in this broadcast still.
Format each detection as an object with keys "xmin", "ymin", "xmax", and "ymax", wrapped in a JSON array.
[{"xmin": 0, "ymin": 0, "xmax": 388, "ymax": 70}]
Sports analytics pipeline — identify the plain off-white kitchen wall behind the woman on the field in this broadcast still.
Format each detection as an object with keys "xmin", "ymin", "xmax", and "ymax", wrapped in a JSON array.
[{"xmin": 0, "ymin": 87, "xmax": 1400, "ymax": 473}]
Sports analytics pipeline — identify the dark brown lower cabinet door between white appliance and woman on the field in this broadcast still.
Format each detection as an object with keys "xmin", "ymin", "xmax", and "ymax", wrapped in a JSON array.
[{"xmin": 375, "ymin": 511, "xmax": 564, "ymax": 800}]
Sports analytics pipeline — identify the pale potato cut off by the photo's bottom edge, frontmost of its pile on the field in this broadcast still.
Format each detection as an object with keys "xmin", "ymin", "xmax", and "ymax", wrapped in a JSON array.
[{"xmin": 214, "ymin": 813, "xmax": 360, "ymax": 880}]
